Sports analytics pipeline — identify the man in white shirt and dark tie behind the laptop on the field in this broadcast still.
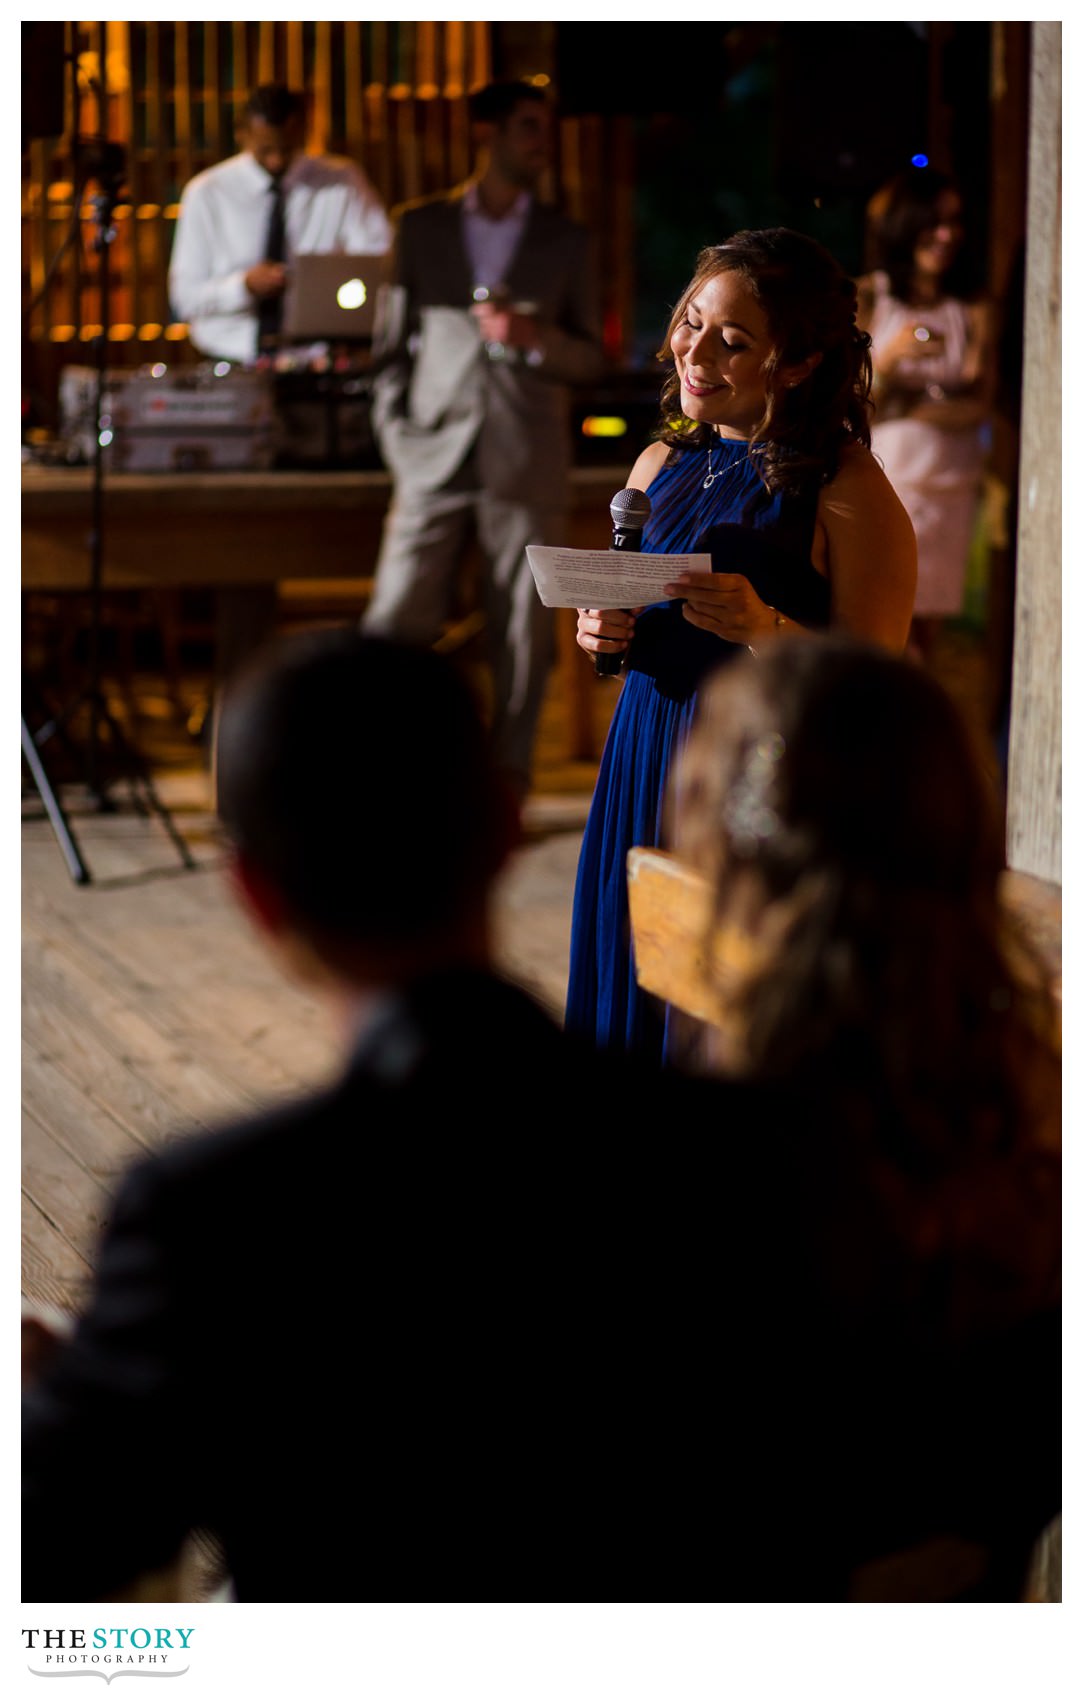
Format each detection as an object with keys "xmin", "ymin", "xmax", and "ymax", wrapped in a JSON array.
[{"xmin": 168, "ymin": 83, "xmax": 391, "ymax": 360}]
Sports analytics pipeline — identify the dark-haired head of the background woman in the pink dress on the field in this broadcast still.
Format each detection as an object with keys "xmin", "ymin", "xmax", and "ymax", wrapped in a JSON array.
[{"xmin": 865, "ymin": 165, "xmax": 974, "ymax": 301}]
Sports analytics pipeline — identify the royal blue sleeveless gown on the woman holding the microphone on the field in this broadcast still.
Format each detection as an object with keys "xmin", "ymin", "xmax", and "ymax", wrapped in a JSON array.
[{"xmin": 564, "ymin": 439, "xmax": 830, "ymax": 1064}]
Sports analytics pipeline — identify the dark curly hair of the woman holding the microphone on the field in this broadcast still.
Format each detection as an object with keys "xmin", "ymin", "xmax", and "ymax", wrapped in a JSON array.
[{"xmin": 658, "ymin": 230, "xmax": 870, "ymax": 490}]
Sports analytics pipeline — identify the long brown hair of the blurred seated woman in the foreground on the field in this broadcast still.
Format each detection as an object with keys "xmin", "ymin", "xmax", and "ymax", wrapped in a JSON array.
[{"xmin": 670, "ymin": 639, "xmax": 1059, "ymax": 1309}]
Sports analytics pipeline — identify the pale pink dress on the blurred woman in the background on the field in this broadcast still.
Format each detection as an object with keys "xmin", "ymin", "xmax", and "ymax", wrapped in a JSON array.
[{"xmin": 869, "ymin": 272, "xmax": 984, "ymax": 615}]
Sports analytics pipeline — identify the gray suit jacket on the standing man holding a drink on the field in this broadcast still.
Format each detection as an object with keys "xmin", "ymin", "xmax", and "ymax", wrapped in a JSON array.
[{"xmin": 374, "ymin": 184, "xmax": 602, "ymax": 508}]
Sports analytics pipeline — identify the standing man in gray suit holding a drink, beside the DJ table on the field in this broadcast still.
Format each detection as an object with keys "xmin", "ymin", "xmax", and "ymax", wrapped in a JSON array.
[{"xmin": 364, "ymin": 83, "xmax": 602, "ymax": 796}]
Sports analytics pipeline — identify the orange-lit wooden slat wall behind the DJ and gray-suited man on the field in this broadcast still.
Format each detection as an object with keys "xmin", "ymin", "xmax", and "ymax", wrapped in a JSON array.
[{"xmin": 22, "ymin": 20, "xmax": 632, "ymax": 401}]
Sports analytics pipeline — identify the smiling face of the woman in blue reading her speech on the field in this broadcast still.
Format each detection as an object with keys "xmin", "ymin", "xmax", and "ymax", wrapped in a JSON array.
[{"xmin": 670, "ymin": 272, "xmax": 772, "ymax": 437}]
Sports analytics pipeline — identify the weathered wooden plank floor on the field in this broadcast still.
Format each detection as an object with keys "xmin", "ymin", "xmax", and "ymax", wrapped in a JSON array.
[{"xmin": 22, "ymin": 656, "xmax": 615, "ymax": 1311}]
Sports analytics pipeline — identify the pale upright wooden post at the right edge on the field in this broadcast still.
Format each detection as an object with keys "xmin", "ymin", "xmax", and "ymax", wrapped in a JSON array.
[{"xmin": 1006, "ymin": 22, "xmax": 1061, "ymax": 884}]
